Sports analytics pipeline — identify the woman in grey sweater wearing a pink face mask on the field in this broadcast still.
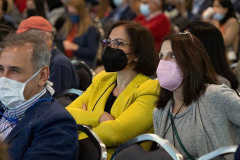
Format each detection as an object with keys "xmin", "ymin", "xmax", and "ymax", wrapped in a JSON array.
[{"xmin": 153, "ymin": 32, "xmax": 240, "ymax": 159}]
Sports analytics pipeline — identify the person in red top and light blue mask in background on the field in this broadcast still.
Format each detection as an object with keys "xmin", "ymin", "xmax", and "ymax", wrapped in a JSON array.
[{"xmin": 134, "ymin": 0, "xmax": 171, "ymax": 51}]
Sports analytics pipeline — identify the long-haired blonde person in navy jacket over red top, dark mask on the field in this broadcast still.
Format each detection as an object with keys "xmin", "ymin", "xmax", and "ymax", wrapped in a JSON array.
[{"xmin": 60, "ymin": 0, "xmax": 100, "ymax": 68}]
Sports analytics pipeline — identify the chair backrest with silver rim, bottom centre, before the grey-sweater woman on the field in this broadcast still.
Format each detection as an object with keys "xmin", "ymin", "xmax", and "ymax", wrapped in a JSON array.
[{"xmin": 111, "ymin": 134, "xmax": 183, "ymax": 160}]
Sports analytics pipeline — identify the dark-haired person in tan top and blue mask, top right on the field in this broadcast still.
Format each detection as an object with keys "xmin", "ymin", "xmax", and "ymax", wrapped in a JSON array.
[{"xmin": 203, "ymin": 0, "xmax": 239, "ymax": 63}]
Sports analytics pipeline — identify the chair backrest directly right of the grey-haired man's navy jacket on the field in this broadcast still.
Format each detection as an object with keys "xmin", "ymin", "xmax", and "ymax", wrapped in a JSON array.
[{"xmin": 78, "ymin": 125, "xmax": 107, "ymax": 160}]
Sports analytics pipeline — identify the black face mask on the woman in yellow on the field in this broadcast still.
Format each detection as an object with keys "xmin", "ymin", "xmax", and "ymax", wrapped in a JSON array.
[{"xmin": 102, "ymin": 46, "xmax": 128, "ymax": 72}]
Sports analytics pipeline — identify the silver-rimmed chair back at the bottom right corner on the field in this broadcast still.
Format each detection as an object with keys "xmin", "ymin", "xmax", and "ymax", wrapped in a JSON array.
[{"xmin": 198, "ymin": 145, "xmax": 238, "ymax": 160}]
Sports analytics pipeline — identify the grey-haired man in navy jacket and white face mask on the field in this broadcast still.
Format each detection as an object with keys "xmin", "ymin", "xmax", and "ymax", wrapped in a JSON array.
[{"xmin": 0, "ymin": 34, "xmax": 78, "ymax": 160}]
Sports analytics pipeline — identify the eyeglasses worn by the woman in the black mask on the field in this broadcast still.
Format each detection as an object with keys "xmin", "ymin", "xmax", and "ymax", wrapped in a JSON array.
[{"xmin": 101, "ymin": 39, "xmax": 130, "ymax": 49}]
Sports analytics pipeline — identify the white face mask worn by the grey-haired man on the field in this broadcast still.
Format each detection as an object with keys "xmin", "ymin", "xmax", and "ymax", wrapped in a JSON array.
[{"xmin": 0, "ymin": 68, "xmax": 42, "ymax": 108}]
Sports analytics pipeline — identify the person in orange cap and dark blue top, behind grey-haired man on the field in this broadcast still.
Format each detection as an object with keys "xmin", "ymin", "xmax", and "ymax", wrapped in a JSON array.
[{"xmin": 17, "ymin": 16, "xmax": 79, "ymax": 96}]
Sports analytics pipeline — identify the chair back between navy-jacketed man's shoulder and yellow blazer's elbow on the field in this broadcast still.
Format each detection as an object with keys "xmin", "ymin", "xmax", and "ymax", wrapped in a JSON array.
[{"xmin": 56, "ymin": 88, "xmax": 83, "ymax": 107}]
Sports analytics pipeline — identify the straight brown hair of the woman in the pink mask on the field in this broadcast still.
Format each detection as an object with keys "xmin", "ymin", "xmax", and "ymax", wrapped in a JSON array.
[{"xmin": 157, "ymin": 33, "xmax": 217, "ymax": 108}]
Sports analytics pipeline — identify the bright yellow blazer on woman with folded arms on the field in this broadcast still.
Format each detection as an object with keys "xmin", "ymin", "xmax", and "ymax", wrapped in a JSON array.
[{"xmin": 66, "ymin": 71, "xmax": 160, "ymax": 158}]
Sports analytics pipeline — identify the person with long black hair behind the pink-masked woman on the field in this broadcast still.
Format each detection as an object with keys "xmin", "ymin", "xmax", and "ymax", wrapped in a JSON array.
[{"xmin": 185, "ymin": 21, "xmax": 238, "ymax": 90}]
